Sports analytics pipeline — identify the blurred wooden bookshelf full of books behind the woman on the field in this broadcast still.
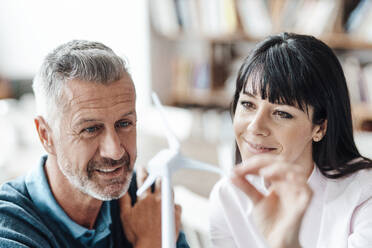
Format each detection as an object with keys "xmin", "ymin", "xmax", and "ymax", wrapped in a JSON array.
[{"xmin": 149, "ymin": 0, "xmax": 372, "ymax": 130}]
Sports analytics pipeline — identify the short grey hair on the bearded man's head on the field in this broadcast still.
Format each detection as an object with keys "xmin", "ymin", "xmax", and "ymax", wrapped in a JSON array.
[{"xmin": 32, "ymin": 40, "xmax": 130, "ymax": 126}]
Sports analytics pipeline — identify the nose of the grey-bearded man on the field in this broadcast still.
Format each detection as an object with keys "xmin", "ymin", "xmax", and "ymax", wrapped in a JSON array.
[{"xmin": 100, "ymin": 130, "xmax": 125, "ymax": 160}]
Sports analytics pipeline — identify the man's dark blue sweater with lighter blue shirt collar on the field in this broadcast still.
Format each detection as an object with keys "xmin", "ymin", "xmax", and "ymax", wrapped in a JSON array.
[{"xmin": 0, "ymin": 156, "xmax": 189, "ymax": 248}]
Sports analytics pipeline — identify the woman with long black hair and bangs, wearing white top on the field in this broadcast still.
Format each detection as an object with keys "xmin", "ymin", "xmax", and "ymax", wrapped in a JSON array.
[{"xmin": 210, "ymin": 33, "xmax": 372, "ymax": 248}]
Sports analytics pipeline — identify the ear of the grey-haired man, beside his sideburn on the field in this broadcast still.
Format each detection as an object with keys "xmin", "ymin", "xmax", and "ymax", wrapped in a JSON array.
[{"xmin": 34, "ymin": 116, "xmax": 55, "ymax": 155}]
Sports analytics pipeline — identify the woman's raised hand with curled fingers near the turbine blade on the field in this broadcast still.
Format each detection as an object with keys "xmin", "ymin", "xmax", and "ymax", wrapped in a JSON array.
[{"xmin": 231, "ymin": 155, "xmax": 312, "ymax": 248}]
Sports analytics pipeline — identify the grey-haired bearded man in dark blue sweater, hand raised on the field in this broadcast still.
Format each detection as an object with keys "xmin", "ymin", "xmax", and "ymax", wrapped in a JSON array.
[{"xmin": 0, "ymin": 40, "xmax": 188, "ymax": 248}]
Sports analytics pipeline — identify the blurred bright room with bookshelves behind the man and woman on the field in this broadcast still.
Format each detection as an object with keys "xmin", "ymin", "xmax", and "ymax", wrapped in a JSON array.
[{"xmin": 0, "ymin": 0, "xmax": 372, "ymax": 248}]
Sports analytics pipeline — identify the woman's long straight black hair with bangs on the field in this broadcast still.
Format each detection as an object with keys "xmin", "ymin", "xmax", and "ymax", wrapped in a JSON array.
[{"xmin": 231, "ymin": 33, "xmax": 372, "ymax": 178}]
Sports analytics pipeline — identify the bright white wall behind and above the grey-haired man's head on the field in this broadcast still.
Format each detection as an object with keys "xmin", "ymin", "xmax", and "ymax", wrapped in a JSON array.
[{"xmin": 0, "ymin": 0, "xmax": 150, "ymax": 107}]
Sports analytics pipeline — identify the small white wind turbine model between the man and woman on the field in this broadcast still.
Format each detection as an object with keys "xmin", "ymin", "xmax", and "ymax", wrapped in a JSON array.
[{"xmin": 137, "ymin": 93, "xmax": 222, "ymax": 248}]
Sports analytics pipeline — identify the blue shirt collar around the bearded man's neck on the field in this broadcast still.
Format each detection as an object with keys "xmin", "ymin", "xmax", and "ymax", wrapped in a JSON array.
[{"xmin": 25, "ymin": 156, "xmax": 112, "ymax": 239}]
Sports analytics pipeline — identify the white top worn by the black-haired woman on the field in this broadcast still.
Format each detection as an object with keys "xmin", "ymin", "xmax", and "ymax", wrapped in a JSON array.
[{"xmin": 210, "ymin": 167, "xmax": 372, "ymax": 248}]
